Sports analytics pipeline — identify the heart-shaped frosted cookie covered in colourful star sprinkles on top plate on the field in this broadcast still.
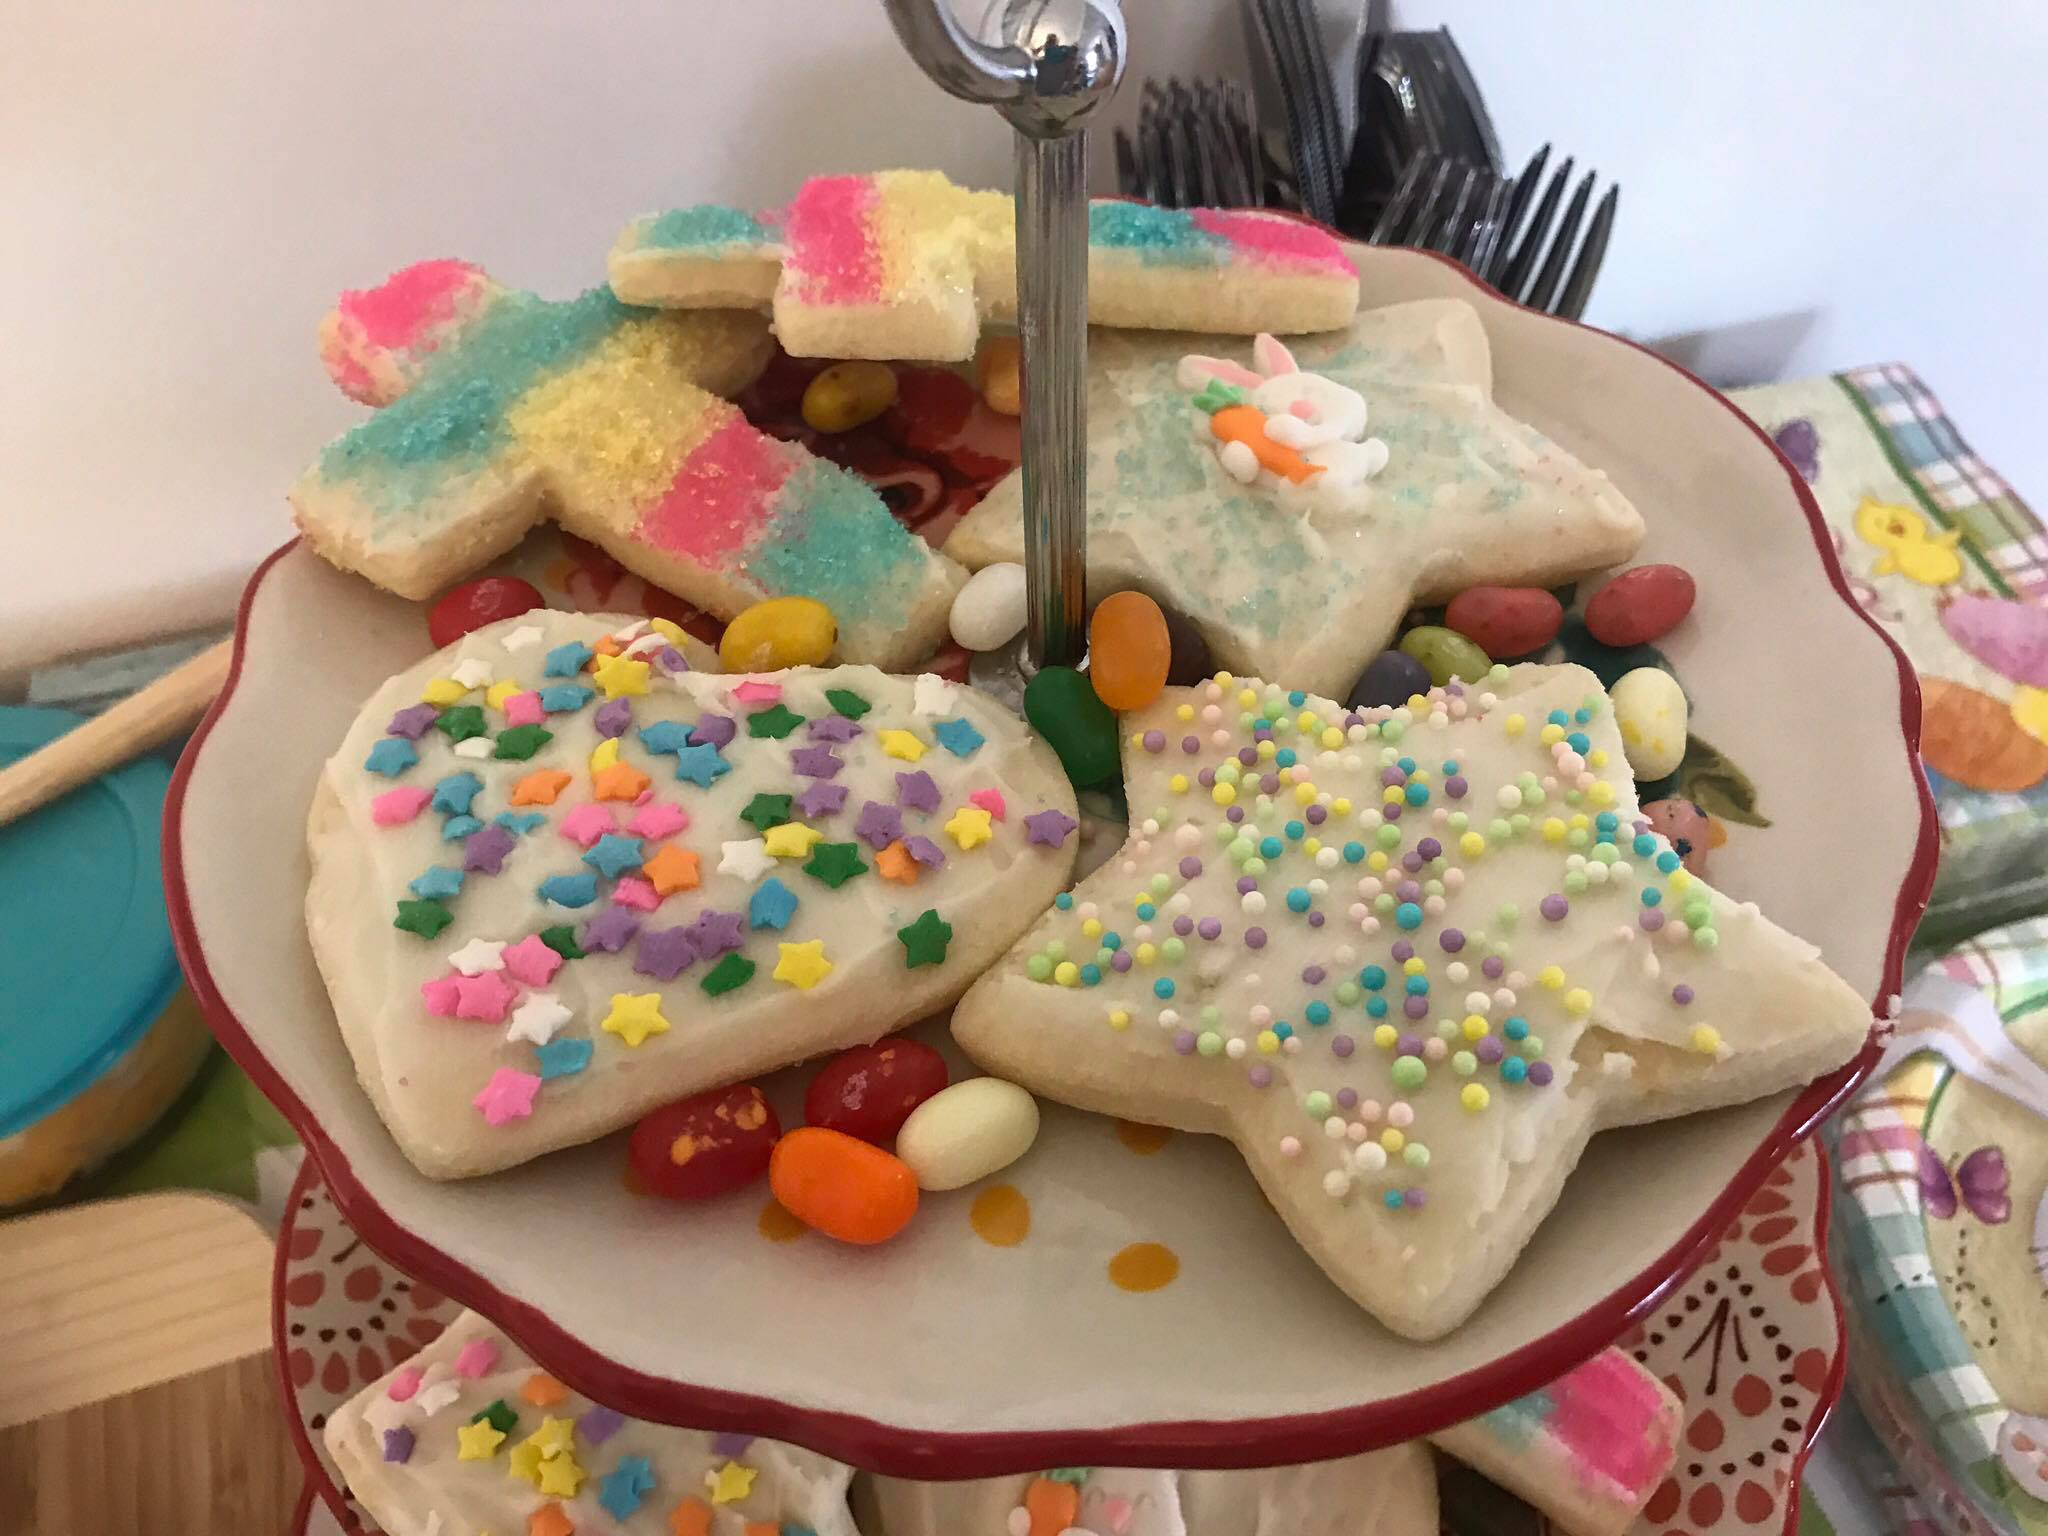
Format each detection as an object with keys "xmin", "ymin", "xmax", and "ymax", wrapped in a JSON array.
[{"xmin": 307, "ymin": 610, "xmax": 1075, "ymax": 1178}]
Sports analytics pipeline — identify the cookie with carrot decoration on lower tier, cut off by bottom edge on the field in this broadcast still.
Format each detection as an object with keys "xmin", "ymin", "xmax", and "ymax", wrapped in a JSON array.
[{"xmin": 872, "ymin": 1440, "xmax": 1438, "ymax": 1536}]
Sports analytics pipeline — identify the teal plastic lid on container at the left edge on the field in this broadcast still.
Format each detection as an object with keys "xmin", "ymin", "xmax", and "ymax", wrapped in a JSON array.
[{"xmin": 0, "ymin": 709, "xmax": 180, "ymax": 1137}]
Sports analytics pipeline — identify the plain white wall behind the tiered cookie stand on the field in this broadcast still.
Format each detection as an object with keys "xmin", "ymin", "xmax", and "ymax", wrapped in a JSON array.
[{"xmin": 0, "ymin": 0, "xmax": 2048, "ymax": 672}]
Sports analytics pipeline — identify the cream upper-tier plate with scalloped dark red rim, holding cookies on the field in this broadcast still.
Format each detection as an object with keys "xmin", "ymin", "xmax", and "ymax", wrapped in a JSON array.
[{"xmin": 166, "ymin": 252, "xmax": 1935, "ymax": 1477}]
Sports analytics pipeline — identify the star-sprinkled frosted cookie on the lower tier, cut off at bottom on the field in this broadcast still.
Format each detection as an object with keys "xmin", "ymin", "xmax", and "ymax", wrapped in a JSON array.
[{"xmin": 322, "ymin": 1313, "xmax": 860, "ymax": 1536}]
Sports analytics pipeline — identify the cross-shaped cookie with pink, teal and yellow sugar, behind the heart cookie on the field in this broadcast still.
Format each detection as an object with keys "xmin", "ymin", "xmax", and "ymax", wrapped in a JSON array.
[{"xmin": 291, "ymin": 262, "xmax": 965, "ymax": 668}]
